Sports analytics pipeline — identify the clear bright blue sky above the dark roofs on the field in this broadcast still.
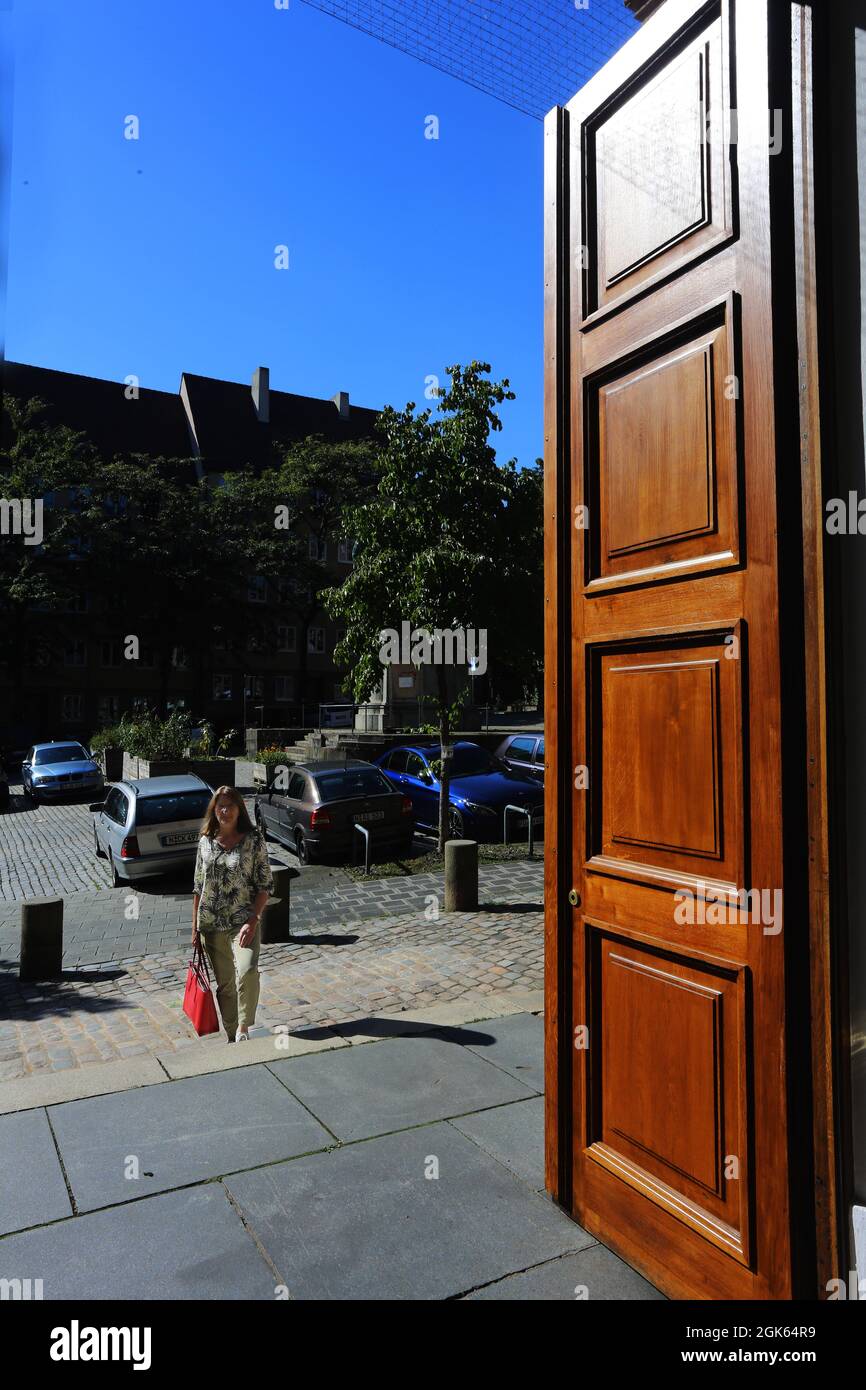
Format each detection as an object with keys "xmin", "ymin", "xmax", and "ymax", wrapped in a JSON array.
[{"xmin": 6, "ymin": 0, "xmax": 628, "ymax": 463}]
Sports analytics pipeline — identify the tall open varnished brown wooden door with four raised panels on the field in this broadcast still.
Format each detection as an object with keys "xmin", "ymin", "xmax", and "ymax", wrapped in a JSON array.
[{"xmin": 546, "ymin": 0, "xmax": 820, "ymax": 1298}]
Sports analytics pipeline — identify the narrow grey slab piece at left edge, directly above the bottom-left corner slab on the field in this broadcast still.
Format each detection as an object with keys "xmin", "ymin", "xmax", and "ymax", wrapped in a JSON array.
[{"xmin": 0, "ymin": 1111, "xmax": 72, "ymax": 1236}]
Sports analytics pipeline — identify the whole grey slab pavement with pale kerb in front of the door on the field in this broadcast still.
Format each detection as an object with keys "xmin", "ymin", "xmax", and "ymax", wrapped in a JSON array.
[{"xmin": 0, "ymin": 990, "xmax": 662, "ymax": 1300}]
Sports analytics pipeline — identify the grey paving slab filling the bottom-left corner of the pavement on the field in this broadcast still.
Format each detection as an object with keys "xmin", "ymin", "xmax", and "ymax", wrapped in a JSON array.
[{"xmin": 0, "ymin": 1183, "xmax": 275, "ymax": 1295}]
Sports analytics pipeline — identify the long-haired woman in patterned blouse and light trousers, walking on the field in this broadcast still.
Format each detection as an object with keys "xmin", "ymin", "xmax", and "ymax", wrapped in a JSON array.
[{"xmin": 192, "ymin": 787, "xmax": 274, "ymax": 1043}]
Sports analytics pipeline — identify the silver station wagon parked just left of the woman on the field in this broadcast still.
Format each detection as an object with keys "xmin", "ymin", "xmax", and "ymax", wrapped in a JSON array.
[{"xmin": 90, "ymin": 773, "xmax": 213, "ymax": 888}]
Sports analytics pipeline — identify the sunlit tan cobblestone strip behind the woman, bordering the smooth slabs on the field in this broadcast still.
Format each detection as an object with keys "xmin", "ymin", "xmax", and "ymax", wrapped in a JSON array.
[{"xmin": 0, "ymin": 905, "xmax": 544, "ymax": 1080}]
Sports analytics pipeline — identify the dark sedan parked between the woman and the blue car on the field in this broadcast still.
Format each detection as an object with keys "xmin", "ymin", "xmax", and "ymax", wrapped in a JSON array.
[{"xmin": 256, "ymin": 758, "xmax": 414, "ymax": 865}]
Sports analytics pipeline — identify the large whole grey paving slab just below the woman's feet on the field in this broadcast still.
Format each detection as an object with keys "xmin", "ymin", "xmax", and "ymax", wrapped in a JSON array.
[{"xmin": 49, "ymin": 1043, "xmax": 335, "ymax": 1211}]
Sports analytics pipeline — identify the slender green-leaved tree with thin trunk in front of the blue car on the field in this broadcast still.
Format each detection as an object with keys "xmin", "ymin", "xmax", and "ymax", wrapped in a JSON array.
[{"xmin": 322, "ymin": 361, "xmax": 537, "ymax": 852}]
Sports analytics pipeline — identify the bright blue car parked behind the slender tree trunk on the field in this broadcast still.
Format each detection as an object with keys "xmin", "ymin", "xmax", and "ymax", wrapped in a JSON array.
[{"xmin": 377, "ymin": 741, "xmax": 544, "ymax": 841}]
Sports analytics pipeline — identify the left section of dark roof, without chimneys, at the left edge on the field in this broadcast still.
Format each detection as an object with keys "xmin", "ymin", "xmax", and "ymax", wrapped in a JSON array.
[{"xmin": 3, "ymin": 361, "xmax": 193, "ymax": 459}]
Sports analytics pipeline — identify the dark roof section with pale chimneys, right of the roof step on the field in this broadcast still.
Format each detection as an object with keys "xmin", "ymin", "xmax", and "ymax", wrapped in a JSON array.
[{"xmin": 183, "ymin": 373, "xmax": 378, "ymax": 470}]
